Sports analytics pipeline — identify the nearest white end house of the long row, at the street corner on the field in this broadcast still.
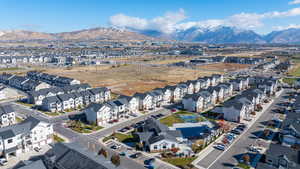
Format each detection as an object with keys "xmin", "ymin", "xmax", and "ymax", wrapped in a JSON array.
[{"xmin": 84, "ymin": 103, "xmax": 117, "ymax": 126}]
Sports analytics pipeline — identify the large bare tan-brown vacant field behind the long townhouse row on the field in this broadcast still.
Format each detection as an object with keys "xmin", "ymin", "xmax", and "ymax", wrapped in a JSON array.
[{"xmin": 44, "ymin": 65, "xmax": 220, "ymax": 95}]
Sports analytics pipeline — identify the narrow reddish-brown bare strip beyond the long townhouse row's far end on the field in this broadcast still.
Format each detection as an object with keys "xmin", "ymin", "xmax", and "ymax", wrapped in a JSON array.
[{"xmin": 197, "ymin": 63, "xmax": 253, "ymax": 72}]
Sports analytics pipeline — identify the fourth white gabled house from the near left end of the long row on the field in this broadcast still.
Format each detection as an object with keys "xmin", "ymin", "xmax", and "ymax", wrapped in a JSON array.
[{"xmin": 132, "ymin": 93, "xmax": 155, "ymax": 110}]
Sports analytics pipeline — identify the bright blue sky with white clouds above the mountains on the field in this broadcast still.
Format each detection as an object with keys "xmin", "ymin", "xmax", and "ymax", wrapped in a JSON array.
[{"xmin": 0, "ymin": 0, "xmax": 300, "ymax": 33}]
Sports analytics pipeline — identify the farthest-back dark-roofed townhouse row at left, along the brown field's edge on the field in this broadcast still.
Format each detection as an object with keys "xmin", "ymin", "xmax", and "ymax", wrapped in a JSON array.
[{"xmin": 27, "ymin": 71, "xmax": 80, "ymax": 87}]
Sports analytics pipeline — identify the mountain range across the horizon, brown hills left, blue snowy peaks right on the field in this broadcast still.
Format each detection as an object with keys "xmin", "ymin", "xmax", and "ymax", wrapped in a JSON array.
[{"xmin": 0, "ymin": 26, "xmax": 300, "ymax": 44}]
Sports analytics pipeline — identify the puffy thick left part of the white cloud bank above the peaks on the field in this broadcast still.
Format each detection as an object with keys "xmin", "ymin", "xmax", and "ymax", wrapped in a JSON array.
[{"xmin": 109, "ymin": 9, "xmax": 186, "ymax": 33}]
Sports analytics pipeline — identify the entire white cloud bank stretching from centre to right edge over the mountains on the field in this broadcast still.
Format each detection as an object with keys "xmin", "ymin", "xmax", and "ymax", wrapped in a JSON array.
[{"xmin": 110, "ymin": 8, "xmax": 300, "ymax": 34}]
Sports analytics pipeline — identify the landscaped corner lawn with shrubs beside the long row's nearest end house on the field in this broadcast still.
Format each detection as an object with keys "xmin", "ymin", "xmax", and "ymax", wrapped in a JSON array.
[{"xmin": 67, "ymin": 121, "xmax": 103, "ymax": 133}]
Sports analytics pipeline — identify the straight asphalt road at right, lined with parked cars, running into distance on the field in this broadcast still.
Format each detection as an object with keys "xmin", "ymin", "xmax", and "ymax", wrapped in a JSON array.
[{"xmin": 198, "ymin": 90, "xmax": 288, "ymax": 169}]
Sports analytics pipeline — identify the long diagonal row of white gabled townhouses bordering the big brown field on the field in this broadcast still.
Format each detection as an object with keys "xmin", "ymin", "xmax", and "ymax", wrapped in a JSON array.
[{"xmin": 84, "ymin": 75, "xmax": 224, "ymax": 125}]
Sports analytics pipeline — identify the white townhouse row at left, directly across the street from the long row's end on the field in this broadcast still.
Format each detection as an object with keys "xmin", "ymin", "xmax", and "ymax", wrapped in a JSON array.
[{"xmin": 40, "ymin": 87, "xmax": 111, "ymax": 112}]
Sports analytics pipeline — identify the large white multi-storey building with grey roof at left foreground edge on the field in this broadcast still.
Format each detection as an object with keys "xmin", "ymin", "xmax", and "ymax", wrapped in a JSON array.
[{"xmin": 0, "ymin": 117, "xmax": 53, "ymax": 158}]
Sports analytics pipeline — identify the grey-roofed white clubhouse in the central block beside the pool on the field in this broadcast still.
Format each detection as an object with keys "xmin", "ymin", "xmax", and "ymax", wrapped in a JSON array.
[{"xmin": 133, "ymin": 118, "xmax": 192, "ymax": 154}]
